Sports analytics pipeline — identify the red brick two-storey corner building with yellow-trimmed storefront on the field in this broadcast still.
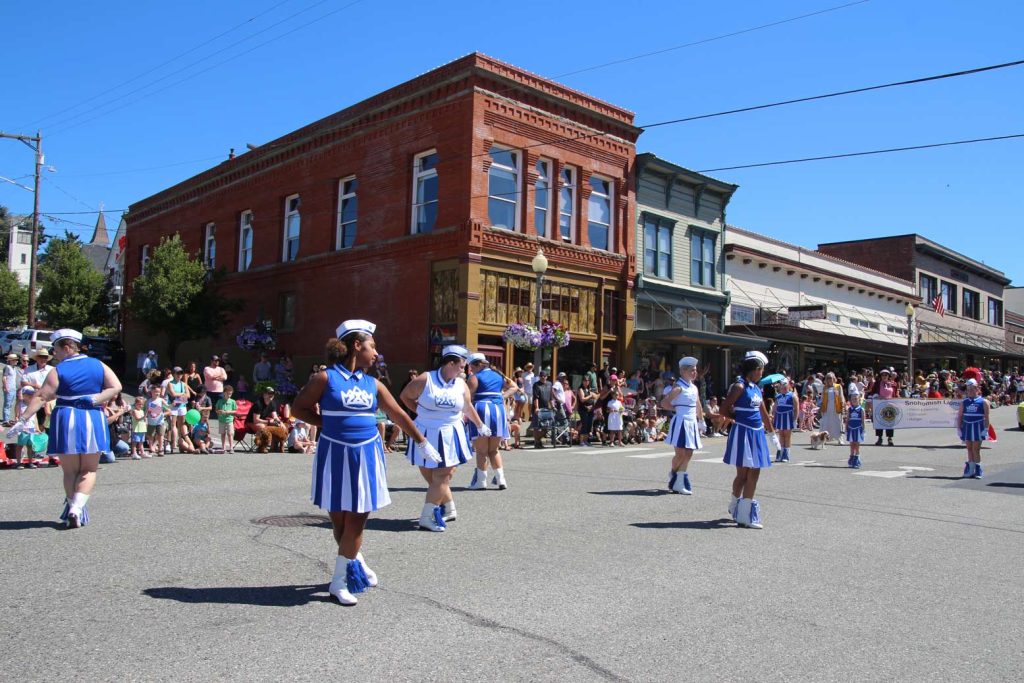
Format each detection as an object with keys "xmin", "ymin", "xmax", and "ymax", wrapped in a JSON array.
[{"xmin": 126, "ymin": 53, "xmax": 640, "ymax": 379}]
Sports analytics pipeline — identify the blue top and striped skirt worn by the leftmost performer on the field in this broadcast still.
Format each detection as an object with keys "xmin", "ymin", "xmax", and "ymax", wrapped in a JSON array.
[{"xmin": 46, "ymin": 355, "xmax": 111, "ymax": 456}]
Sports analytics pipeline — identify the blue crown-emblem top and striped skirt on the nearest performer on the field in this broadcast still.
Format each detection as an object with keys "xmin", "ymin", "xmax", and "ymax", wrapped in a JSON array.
[{"xmin": 311, "ymin": 366, "xmax": 391, "ymax": 512}]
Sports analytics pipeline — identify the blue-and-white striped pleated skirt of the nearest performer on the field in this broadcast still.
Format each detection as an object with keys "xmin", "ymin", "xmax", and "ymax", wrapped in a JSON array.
[{"xmin": 311, "ymin": 434, "xmax": 391, "ymax": 512}]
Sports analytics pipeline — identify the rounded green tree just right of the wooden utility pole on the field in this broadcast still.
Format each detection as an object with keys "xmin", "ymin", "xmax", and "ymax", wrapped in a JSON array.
[{"xmin": 37, "ymin": 232, "xmax": 106, "ymax": 330}]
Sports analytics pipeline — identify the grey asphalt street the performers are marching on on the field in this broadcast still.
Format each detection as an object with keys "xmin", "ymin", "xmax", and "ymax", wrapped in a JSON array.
[{"xmin": 0, "ymin": 409, "xmax": 1024, "ymax": 682}]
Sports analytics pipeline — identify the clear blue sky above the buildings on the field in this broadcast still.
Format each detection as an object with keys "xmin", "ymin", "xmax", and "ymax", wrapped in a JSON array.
[{"xmin": 0, "ymin": 0, "xmax": 1024, "ymax": 284}]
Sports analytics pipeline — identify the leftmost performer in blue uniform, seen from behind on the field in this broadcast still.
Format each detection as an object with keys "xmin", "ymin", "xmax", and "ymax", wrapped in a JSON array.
[{"xmin": 7, "ymin": 329, "xmax": 121, "ymax": 528}]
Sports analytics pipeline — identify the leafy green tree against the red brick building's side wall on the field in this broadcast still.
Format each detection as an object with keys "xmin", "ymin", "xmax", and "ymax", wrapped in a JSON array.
[{"xmin": 127, "ymin": 234, "xmax": 242, "ymax": 359}]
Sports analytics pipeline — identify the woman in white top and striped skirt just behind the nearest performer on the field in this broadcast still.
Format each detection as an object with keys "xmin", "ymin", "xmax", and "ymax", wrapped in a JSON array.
[{"xmin": 399, "ymin": 345, "xmax": 490, "ymax": 531}]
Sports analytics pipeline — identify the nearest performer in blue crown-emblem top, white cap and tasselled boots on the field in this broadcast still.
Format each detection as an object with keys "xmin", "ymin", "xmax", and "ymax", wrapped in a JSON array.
[{"xmin": 292, "ymin": 321, "xmax": 440, "ymax": 605}]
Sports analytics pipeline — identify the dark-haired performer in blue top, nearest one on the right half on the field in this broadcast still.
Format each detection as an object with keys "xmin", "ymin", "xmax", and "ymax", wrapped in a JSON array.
[{"xmin": 720, "ymin": 351, "xmax": 771, "ymax": 528}]
